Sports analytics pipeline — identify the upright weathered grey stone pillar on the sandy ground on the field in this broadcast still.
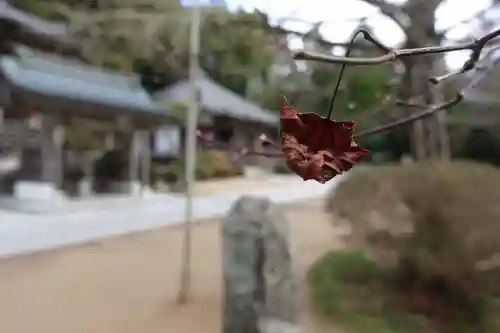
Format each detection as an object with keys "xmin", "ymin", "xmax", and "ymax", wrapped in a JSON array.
[{"xmin": 222, "ymin": 197, "xmax": 300, "ymax": 333}]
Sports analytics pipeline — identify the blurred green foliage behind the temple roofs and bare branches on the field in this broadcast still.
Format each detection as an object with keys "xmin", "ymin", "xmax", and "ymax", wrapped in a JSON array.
[{"xmin": 14, "ymin": 0, "xmax": 500, "ymax": 164}]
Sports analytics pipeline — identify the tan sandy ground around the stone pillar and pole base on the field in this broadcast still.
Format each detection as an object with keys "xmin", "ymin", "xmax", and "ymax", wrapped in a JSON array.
[{"xmin": 0, "ymin": 202, "xmax": 346, "ymax": 333}]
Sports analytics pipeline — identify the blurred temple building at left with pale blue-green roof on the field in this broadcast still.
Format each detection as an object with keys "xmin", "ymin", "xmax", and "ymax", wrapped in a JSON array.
[{"xmin": 0, "ymin": 2, "xmax": 171, "ymax": 203}]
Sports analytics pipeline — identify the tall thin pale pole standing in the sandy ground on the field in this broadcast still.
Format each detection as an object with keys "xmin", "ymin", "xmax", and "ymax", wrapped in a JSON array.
[{"xmin": 177, "ymin": 6, "xmax": 201, "ymax": 304}]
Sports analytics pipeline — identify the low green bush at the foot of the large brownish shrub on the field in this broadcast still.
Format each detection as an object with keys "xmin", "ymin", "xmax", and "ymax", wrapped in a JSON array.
[{"xmin": 307, "ymin": 250, "xmax": 432, "ymax": 333}]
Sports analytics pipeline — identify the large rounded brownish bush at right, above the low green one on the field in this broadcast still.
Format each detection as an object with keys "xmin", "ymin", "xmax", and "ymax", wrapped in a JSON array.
[{"xmin": 326, "ymin": 162, "xmax": 500, "ymax": 330}]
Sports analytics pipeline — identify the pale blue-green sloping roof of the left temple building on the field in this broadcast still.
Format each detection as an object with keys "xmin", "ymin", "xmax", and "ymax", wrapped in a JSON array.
[{"xmin": 0, "ymin": 48, "xmax": 166, "ymax": 116}]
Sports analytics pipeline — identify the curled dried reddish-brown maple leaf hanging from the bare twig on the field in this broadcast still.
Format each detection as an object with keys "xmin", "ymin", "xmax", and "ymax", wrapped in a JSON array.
[{"xmin": 280, "ymin": 102, "xmax": 369, "ymax": 183}]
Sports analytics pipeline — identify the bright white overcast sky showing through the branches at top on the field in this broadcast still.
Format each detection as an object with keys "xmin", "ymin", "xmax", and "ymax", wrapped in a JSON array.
[{"xmin": 226, "ymin": 0, "xmax": 491, "ymax": 67}]
